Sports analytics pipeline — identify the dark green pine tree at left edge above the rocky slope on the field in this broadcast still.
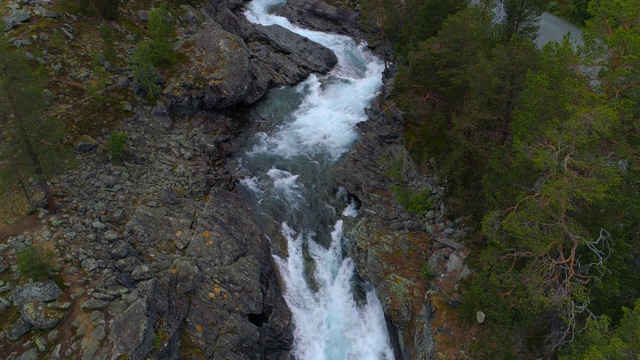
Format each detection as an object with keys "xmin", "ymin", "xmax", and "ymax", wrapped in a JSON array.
[{"xmin": 0, "ymin": 39, "xmax": 70, "ymax": 213}]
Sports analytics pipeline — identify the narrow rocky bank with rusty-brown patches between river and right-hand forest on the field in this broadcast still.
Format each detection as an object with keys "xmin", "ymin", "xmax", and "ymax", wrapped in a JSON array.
[{"xmin": 333, "ymin": 74, "xmax": 473, "ymax": 359}]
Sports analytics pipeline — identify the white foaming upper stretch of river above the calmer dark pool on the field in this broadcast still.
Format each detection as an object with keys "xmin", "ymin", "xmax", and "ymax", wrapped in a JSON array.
[{"xmin": 245, "ymin": 0, "xmax": 383, "ymax": 160}]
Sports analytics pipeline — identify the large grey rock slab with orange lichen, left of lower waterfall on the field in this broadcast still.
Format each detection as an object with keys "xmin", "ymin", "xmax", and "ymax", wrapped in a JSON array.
[{"xmin": 185, "ymin": 188, "xmax": 293, "ymax": 359}]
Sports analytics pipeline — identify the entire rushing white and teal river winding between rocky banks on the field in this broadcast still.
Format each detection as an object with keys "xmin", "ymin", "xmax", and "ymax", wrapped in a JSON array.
[{"xmin": 241, "ymin": 0, "xmax": 393, "ymax": 360}]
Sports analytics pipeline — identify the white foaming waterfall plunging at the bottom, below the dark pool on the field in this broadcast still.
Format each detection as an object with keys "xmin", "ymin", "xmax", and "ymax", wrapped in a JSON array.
[{"xmin": 275, "ymin": 221, "xmax": 393, "ymax": 360}]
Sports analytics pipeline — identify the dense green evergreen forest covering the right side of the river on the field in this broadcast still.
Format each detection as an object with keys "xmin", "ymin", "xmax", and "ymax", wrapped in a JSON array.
[{"xmin": 361, "ymin": 0, "xmax": 640, "ymax": 359}]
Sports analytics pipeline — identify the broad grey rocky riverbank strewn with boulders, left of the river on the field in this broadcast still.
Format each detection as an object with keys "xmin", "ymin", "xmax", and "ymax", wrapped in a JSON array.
[{"xmin": 0, "ymin": 2, "xmax": 350, "ymax": 359}]
